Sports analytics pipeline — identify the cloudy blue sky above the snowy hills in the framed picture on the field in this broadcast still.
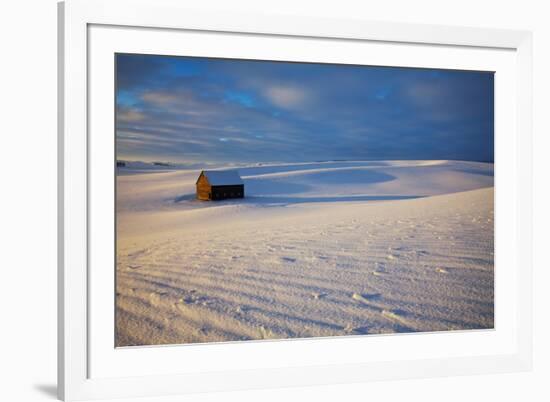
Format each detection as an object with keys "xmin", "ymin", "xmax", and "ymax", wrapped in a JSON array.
[{"xmin": 116, "ymin": 54, "xmax": 494, "ymax": 163}]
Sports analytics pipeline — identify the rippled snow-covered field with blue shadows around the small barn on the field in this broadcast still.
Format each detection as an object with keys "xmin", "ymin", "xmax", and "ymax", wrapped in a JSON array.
[{"xmin": 116, "ymin": 161, "xmax": 494, "ymax": 346}]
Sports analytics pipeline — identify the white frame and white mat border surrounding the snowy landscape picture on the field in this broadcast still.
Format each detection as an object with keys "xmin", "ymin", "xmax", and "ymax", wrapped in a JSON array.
[{"xmin": 58, "ymin": 0, "xmax": 532, "ymax": 400}]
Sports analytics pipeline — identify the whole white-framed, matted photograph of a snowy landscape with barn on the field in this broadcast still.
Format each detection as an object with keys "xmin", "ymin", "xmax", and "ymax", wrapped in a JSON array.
[{"xmin": 58, "ymin": 0, "xmax": 532, "ymax": 400}]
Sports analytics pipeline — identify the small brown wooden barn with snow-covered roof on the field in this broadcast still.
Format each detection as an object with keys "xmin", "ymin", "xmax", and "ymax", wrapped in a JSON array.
[{"xmin": 197, "ymin": 170, "xmax": 244, "ymax": 200}]
